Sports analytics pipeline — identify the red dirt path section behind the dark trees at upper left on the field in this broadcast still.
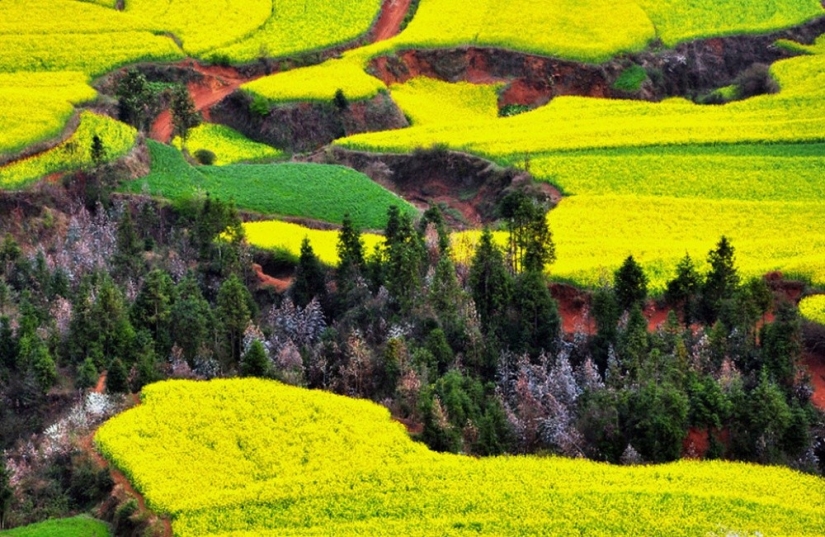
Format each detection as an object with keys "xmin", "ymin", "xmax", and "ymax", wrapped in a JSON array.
[{"xmin": 149, "ymin": 60, "xmax": 258, "ymax": 143}]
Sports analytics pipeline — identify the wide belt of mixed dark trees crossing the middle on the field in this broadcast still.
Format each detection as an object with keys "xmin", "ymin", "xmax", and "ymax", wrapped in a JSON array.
[{"xmin": 0, "ymin": 189, "xmax": 822, "ymax": 524}]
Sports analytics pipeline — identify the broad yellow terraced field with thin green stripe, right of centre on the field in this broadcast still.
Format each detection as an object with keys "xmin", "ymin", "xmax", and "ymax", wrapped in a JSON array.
[{"xmin": 336, "ymin": 37, "xmax": 825, "ymax": 290}]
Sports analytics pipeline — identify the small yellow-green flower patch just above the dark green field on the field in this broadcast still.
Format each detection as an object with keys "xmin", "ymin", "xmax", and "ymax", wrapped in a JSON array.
[{"xmin": 172, "ymin": 123, "xmax": 283, "ymax": 166}]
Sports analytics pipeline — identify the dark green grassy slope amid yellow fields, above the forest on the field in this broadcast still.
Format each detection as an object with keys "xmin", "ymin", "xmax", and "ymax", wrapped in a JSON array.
[{"xmin": 127, "ymin": 141, "xmax": 415, "ymax": 229}]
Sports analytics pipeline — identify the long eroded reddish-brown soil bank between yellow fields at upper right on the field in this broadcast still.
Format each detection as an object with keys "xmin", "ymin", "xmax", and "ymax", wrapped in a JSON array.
[{"xmin": 370, "ymin": 18, "xmax": 825, "ymax": 107}]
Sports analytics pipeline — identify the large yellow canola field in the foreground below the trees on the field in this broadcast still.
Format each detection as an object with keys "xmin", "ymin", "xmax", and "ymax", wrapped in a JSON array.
[{"xmin": 95, "ymin": 379, "xmax": 825, "ymax": 537}]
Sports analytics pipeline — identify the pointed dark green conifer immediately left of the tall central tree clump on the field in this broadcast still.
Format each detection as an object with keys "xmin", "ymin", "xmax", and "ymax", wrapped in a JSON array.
[{"xmin": 469, "ymin": 228, "xmax": 512, "ymax": 333}]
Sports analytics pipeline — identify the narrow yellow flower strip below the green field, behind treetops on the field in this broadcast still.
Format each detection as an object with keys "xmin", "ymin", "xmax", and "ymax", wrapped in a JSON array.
[{"xmin": 243, "ymin": 220, "xmax": 384, "ymax": 267}]
